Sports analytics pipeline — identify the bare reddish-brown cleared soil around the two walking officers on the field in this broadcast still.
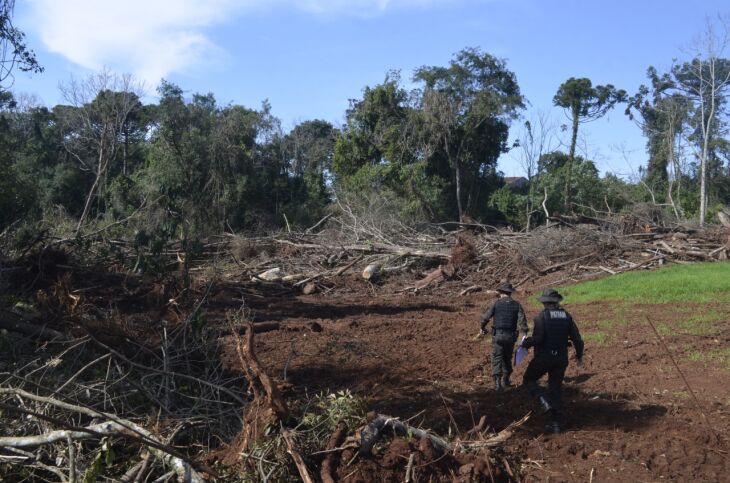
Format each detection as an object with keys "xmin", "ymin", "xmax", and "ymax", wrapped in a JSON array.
[{"xmin": 209, "ymin": 277, "xmax": 730, "ymax": 482}]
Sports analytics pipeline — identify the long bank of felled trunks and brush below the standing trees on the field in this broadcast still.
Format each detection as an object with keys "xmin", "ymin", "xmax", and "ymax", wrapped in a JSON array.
[{"xmin": 223, "ymin": 214, "xmax": 730, "ymax": 294}]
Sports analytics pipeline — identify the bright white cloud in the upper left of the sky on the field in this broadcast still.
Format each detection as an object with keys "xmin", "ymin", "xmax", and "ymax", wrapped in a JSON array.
[{"xmin": 29, "ymin": 0, "xmax": 456, "ymax": 85}]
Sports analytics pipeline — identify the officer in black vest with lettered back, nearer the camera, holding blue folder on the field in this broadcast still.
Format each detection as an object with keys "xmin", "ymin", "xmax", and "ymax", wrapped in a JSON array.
[{"xmin": 522, "ymin": 289, "xmax": 583, "ymax": 433}]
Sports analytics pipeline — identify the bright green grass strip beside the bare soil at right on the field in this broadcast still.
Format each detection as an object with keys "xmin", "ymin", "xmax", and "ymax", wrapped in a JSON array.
[{"xmin": 561, "ymin": 262, "xmax": 730, "ymax": 304}]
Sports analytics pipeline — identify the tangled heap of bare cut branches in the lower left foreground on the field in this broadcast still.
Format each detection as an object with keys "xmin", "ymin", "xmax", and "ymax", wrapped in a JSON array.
[{"xmin": 0, "ymin": 278, "xmax": 247, "ymax": 482}]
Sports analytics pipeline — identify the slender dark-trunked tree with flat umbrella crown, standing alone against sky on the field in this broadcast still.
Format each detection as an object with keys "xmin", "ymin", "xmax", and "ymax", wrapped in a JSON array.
[{"xmin": 553, "ymin": 77, "xmax": 626, "ymax": 211}]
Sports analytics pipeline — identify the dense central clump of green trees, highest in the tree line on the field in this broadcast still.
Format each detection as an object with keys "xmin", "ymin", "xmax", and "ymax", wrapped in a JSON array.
[{"xmin": 333, "ymin": 49, "xmax": 523, "ymax": 220}]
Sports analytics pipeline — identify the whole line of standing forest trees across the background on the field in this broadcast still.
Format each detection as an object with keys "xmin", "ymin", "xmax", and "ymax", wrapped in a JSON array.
[{"xmin": 0, "ymin": 27, "xmax": 730, "ymax": 246}]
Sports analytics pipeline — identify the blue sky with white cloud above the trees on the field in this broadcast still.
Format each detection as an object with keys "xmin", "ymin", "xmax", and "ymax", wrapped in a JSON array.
[{"xmin": 13, "ymin": 0, "xmax": 730, "ymax": 176}]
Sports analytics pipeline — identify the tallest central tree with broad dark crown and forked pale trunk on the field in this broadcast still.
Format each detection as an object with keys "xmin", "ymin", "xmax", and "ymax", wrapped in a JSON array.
[{"xmin": 414, "ymin": 48, "xmax": 524, "ymax": 220}]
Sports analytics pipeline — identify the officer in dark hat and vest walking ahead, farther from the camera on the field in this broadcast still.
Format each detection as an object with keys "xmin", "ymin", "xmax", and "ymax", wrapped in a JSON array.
[{"xmin": 479, "ymin": 282, "xmax": 528, "ymax": 391}]
